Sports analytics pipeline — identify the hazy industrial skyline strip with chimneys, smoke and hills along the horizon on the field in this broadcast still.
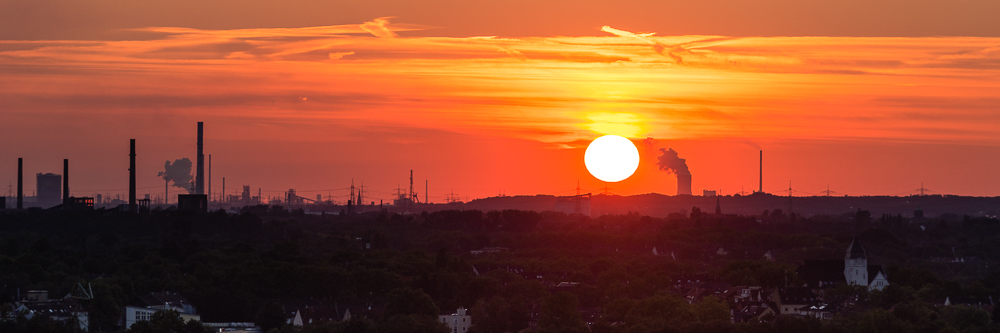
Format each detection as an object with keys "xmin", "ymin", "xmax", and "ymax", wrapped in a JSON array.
[{"xmin": 0, "ymin": 122, "xmax": 1000, "ymax": 216}]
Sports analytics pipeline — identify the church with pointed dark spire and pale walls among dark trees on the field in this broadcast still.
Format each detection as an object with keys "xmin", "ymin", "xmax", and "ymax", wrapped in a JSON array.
[{"xmin": 797, "ymin": 237, "xmax": 889, "ymax": 290}]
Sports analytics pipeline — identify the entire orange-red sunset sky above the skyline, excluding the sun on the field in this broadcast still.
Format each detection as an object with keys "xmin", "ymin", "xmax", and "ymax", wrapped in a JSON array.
[{"xmin": 0, "ymin": 0, "xmax": 1000, "ymax": 203}]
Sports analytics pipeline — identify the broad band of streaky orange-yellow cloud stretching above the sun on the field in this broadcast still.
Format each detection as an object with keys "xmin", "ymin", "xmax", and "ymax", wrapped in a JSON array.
[{"xmin": 0, "ymin": 17, "xmax": 1000, "ymax": 147}]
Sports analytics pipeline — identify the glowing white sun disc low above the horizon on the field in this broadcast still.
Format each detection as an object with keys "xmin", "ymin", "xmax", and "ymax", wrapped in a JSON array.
[{"xmin": 583, "ymin": 135, "xmax": 639, "ymax": 183}]
